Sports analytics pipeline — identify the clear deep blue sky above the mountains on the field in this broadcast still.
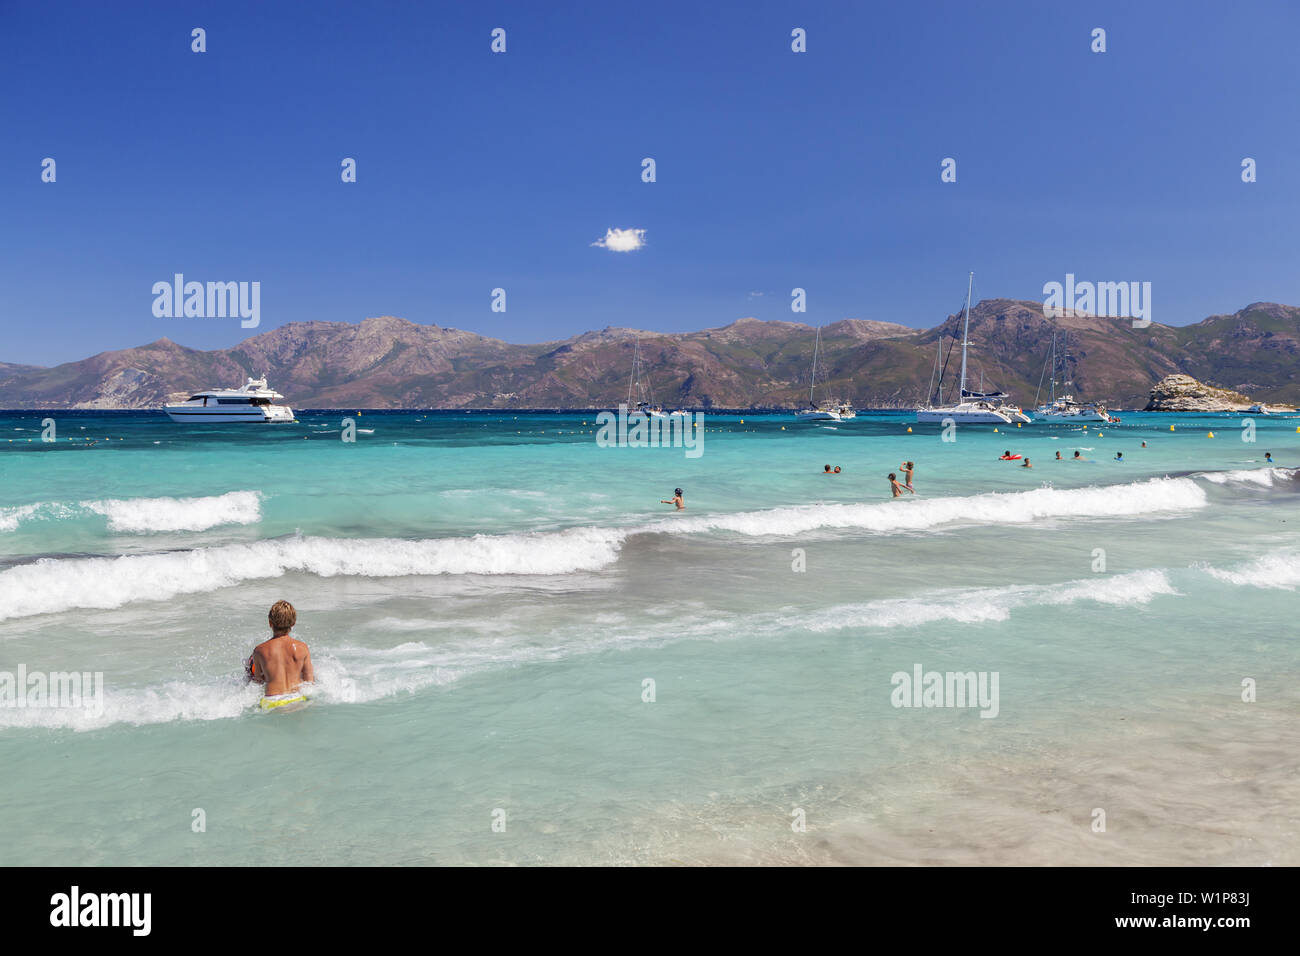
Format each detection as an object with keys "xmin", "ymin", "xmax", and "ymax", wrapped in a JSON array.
[{"xmin": 0, "ymin": 0, "xmax": 1300, "ymax": 364}]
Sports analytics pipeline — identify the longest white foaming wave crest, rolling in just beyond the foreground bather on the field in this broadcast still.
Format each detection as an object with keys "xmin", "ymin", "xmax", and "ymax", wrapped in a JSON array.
[{"xmin": 0, "ymin": 479, "xmax": 1208, "ymax": 620}]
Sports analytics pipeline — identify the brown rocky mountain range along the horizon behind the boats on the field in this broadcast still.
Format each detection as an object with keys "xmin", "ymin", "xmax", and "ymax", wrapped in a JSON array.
[{"xmin": 0, "ymin": 299, "xmax": 1300, "ymax": 408}]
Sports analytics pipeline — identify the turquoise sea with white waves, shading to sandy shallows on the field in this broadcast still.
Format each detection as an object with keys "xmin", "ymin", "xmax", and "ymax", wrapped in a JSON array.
[{"xmin": 0, "ymin": 410, "xmax": 1300, "ymax": 865}]
